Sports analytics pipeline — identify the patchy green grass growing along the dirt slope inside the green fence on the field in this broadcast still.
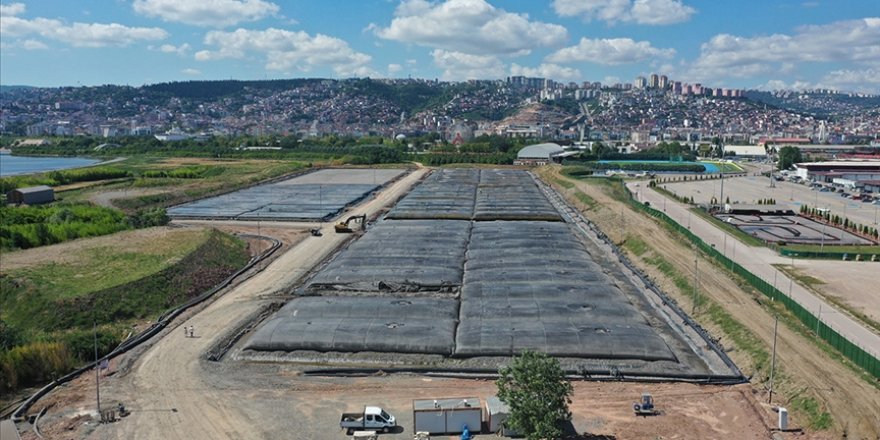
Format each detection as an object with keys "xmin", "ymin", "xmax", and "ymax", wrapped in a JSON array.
[{"xmin": 547, "ymin": 168, "xmax": 839, "ymax": 430}]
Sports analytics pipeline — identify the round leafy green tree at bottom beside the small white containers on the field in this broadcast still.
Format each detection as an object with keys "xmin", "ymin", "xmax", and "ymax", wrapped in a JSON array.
[{"xmin": 495, "ymin": 350, "xmax": 574, "ymax": 440}]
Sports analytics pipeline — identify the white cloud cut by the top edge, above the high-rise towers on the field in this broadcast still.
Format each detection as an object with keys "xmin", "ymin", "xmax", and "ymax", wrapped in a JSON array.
[{"xmin": 553, "ymin": 0, "xmax": 696, "ymax": 25}]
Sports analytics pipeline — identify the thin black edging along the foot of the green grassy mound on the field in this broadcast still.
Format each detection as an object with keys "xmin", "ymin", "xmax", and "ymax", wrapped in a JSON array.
[{"xmin": 11, "ymin": 234, "xmax": 281, "ymax": 422}]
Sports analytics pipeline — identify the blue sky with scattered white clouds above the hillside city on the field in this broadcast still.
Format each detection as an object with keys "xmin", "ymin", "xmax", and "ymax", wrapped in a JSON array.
[{"xmin": 0, "ymin": 0, "xmax": 880, "ymax": 93}]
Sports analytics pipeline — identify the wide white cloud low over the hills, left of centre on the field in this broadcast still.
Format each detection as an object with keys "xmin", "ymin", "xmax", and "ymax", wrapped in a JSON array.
[{"xmin": 195, "ymin": 28, "xmax": 376, "ymax": 77}]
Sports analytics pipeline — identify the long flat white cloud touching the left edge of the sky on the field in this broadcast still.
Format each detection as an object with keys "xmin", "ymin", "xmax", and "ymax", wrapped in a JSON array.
[{"xmin": 0, "ymin": 15, "xmax": 168, "ymax": 47}]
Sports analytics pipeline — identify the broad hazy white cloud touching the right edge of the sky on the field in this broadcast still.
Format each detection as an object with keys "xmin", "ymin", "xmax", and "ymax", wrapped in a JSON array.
[{"xmin": 688, "ymin": 17, "xmax": 880, "ymax": 80}]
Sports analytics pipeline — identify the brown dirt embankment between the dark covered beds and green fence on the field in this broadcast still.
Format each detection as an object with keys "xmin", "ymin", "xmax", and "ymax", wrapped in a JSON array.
[{"xmin": 539, "ymin": 167, "xmax": 880, "ymax": 438}]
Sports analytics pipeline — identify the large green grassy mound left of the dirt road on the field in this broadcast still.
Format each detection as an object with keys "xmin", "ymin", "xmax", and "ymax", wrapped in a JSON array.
[{"xmin": 0, "ymin": 228, "xmax": 249, "ymax": 394}]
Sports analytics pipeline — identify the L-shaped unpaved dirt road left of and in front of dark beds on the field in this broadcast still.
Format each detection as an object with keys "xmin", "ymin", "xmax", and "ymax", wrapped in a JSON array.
[{"xmin": 22, "ymin": 167, "xmax": 773, "ymax": 440}]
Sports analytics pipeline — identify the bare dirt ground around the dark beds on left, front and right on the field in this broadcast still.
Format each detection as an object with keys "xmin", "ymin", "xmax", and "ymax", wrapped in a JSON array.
[{"xmin": 13, "ymin": 166, "xmax": 880, "ymax": 439}]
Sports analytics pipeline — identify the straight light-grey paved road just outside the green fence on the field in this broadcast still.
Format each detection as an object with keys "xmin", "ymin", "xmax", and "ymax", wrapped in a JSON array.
[{"xmin": 627, "ymin": 182, "xmax": 880, "ymax": 357}]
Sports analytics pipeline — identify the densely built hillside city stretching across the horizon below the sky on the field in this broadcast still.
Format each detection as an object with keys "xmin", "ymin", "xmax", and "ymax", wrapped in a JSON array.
[{"xmin": 0, "ymin": 74, "xmax": 880, "ymax": 149}]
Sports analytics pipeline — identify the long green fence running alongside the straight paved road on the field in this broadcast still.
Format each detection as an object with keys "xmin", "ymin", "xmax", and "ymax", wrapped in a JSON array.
[{"xmin": 621, "ymin": 182, "xmax": 880, "ymax": 378}]
